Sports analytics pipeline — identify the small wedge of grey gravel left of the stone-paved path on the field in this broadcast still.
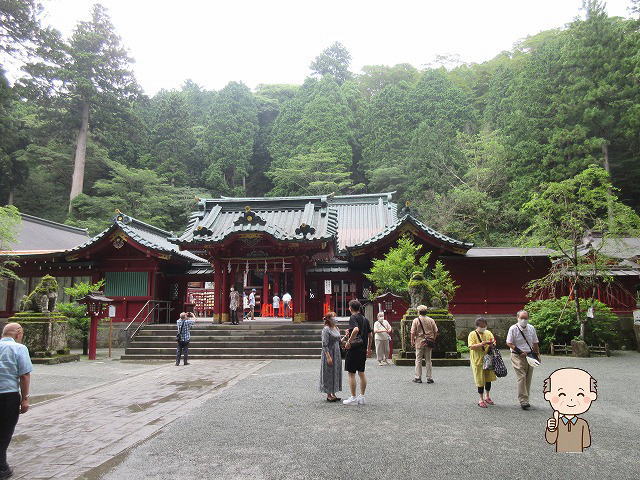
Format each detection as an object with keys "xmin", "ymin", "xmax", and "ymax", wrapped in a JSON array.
[{"xmin": 30, "ymin": 349, "xmax": 166, "ymax": 405}]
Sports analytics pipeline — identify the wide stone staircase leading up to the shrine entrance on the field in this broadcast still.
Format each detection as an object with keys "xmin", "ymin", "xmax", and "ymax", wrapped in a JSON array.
[{"xmin": 121, "ymin": 323, "xmax": 346, "ymax": 360}]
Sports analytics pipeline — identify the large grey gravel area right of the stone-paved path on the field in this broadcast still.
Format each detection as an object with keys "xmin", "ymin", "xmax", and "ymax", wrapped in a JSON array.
[{"xmin": 100, "ymin": 352, "xmax": 640, "ymax": 480}]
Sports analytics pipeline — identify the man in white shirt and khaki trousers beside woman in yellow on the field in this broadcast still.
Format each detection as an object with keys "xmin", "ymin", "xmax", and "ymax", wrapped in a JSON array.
[{"xmin": 506, "ymin": 310, "xmax": 540, "ymax": 410}]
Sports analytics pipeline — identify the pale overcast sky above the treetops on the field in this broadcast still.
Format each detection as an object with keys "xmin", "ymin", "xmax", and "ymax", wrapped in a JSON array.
[{"xmin": 38, "ymin": 0, "xmax": 629, "ymax": 94}]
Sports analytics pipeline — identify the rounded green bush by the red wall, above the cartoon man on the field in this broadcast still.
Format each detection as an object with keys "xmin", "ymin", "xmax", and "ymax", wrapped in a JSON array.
[{"xmin": 525, "ymin": 297, "xmax": 618, "ymax": 351}]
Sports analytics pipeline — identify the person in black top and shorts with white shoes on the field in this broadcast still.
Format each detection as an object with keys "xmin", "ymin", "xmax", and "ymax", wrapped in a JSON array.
[{"xmin": 342, "ymin": 300, "xmax": 371, "ymax": 405}]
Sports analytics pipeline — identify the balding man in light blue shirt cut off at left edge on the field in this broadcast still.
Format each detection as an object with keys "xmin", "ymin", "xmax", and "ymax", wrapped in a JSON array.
[{"xmin": 0, "ymin": 323, "xmax": 32, "ymax": 479}]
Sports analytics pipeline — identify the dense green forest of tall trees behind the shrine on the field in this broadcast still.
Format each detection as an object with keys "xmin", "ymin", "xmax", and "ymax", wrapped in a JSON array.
[{"xmin": 0, "ymin": 0, "xmax": 640, "ymax": 246}]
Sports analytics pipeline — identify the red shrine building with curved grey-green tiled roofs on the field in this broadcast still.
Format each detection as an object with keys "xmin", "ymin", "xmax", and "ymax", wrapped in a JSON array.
[{"xmin": 0, "ymin": 193, "xmax": 640, "ymax": 322}]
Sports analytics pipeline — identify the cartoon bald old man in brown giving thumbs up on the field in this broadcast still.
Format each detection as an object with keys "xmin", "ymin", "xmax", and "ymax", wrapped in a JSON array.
[{"xmin": 544, "ymin": 368, "xmax": 598, "ymax": 452}]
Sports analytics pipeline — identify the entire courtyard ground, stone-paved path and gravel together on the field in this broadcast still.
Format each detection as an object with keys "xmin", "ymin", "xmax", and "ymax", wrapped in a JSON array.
[{"xmin": 9, "ymin": 352, "xmax": 640, "ymax": 480}]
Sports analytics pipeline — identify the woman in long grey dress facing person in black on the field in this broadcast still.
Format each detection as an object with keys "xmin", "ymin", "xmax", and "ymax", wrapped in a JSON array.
[{"xmin": 320, "ymin": 312, "xmax": 342, "ymax": 402}]
